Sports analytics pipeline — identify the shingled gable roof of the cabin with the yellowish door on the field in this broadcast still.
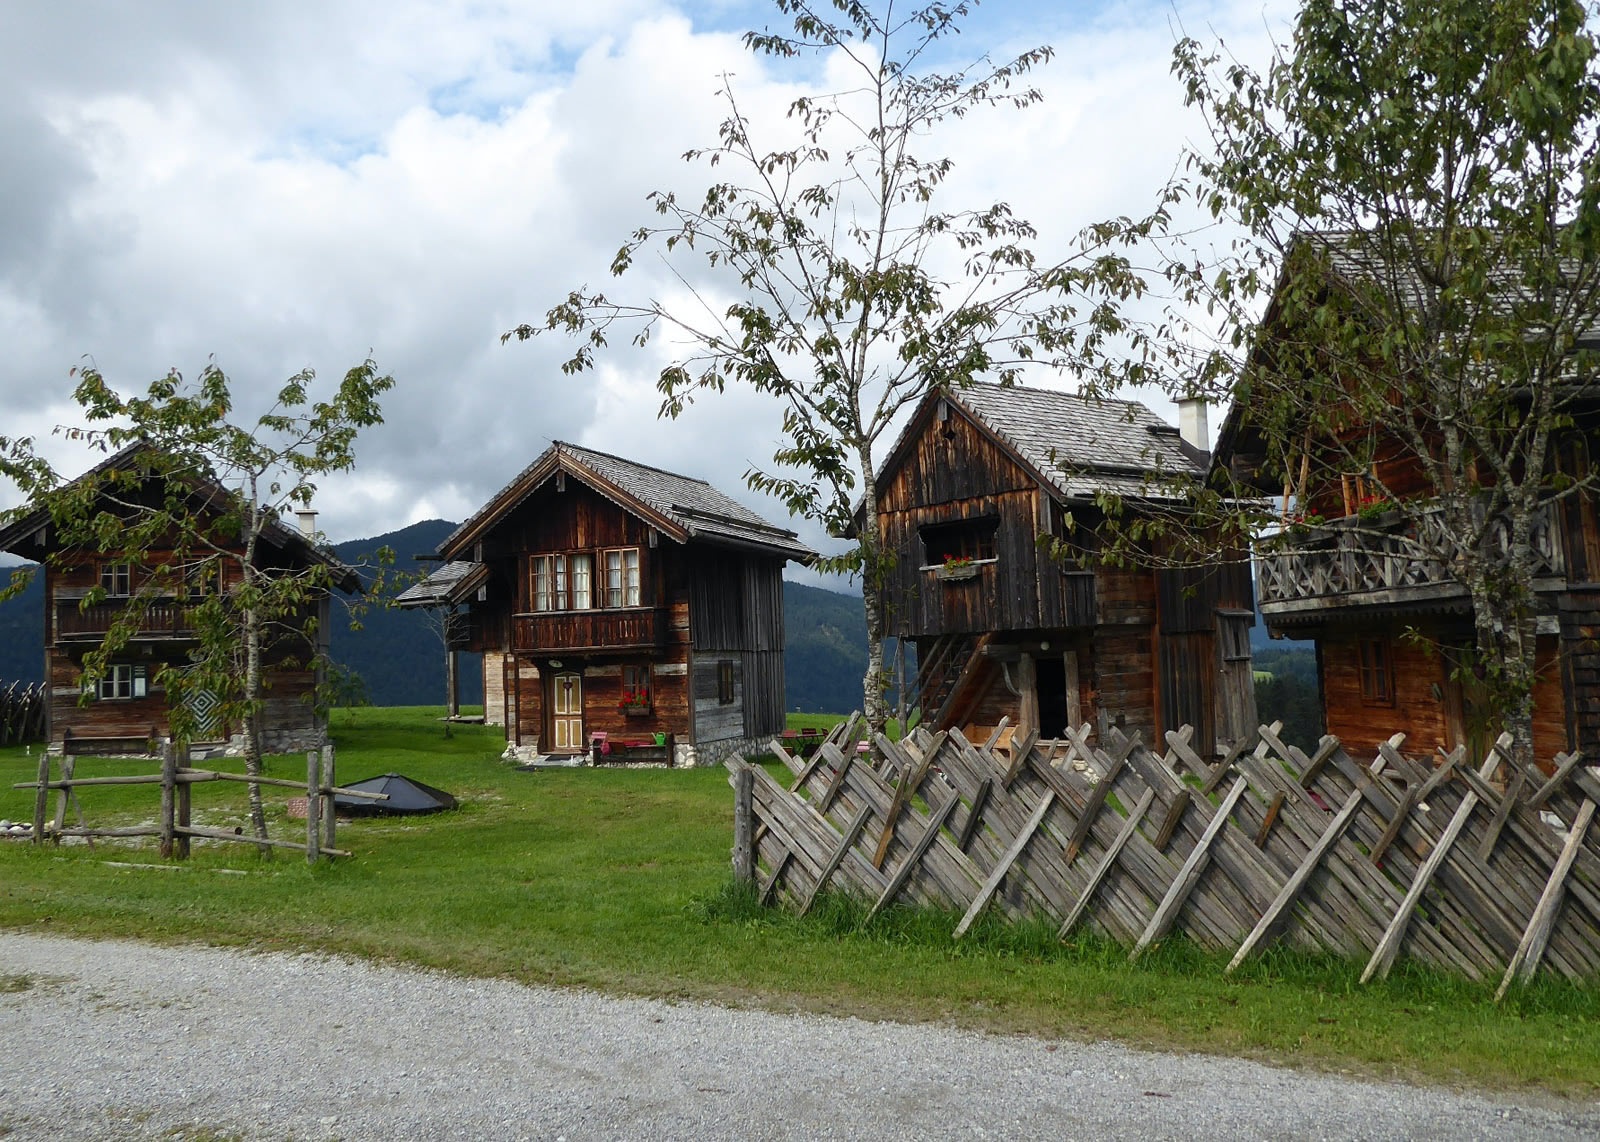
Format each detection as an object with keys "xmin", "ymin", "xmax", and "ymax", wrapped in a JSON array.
[{"xmin": 438, "ymin": 440, "xmax": 816, "ymax": 563}]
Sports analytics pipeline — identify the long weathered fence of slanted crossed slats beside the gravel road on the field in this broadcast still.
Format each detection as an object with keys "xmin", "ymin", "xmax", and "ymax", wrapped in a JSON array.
[{"xmin": 728, "ymin": 720, "xmax": 1600, "ymax": 995}]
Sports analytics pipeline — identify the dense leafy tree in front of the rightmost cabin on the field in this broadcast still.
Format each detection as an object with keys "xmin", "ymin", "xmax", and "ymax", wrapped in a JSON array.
[{"xmin": 1170, "ymin": 0, "xmax": 1600, "ymax": 758}]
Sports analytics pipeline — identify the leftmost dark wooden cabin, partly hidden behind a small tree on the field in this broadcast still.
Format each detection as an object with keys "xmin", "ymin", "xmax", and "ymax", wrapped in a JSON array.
[{"xmin": 0, "ymin": 443, "xmax": 362, "ymax": 753}]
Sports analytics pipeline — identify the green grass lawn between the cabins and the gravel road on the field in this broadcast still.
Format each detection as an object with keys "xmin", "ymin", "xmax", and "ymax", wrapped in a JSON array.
[{"xmin": 0, "ymin": 709, "xmax": 1600, "ymax": 1097}]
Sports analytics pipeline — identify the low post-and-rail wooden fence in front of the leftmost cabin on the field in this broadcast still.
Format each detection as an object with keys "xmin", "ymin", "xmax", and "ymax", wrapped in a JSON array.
[{"xmin": 11, "ymin": 739, "xmax": 380, "ymax": 864}]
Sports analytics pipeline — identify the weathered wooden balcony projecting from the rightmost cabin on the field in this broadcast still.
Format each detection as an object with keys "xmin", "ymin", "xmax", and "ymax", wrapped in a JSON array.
[{"xmin": 1256, "ymin": 510, "xmax": 1566, "ymax": 621}]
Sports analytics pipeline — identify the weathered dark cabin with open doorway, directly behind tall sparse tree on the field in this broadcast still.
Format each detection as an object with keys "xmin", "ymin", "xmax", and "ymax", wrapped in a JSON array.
[{"xmin": 878, "ymin": 384, "xmax": 1256, "ymax": 755}]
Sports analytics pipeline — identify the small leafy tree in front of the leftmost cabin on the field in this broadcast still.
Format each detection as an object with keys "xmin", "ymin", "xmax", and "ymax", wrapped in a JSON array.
[{"xmin": 0, "ymin": 360, "xmax": 394, "ymax": 853}]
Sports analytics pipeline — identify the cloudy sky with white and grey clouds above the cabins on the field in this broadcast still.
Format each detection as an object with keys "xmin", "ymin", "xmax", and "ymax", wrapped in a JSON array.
[{"xmin": 0, "ymin": 0, "xmax": 1291, "ymax": 569}]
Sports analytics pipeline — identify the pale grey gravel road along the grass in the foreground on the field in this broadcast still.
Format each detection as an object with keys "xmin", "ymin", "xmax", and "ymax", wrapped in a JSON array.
[{"xmin": 0, "ymin": 932, "xmax": 1600, "ymax": 1142}]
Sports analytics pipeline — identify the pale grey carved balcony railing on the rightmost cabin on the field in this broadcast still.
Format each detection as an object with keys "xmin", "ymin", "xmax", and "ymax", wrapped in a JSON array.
[{"xmin": 1256, "ymin": 507, "xmax": 1565, "ymax": 605}]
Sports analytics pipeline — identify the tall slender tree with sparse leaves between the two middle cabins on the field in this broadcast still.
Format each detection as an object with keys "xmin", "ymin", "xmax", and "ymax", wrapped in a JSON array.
[{"xmin": 506, "ymin": 0, "xmax": 1150, "ymax": 731}]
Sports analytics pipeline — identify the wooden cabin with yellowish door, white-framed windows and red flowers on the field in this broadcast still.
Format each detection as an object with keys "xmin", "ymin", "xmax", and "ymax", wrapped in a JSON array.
[{"xmin": 400, "ymin": 441, "xmax": 814, "ymax": 765}]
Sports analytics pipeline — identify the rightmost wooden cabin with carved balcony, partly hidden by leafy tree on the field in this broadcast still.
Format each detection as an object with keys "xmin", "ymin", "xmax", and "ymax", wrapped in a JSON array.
[{"xmin": 1216, "ymin": 231, "xmax": 1600, "ymax": 763}]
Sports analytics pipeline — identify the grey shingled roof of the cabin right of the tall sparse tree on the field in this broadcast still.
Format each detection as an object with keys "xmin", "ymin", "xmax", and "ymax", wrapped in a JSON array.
[{"xmin": 880, "ymin": 384, "xmax": 1205, "ymax": 501}]
